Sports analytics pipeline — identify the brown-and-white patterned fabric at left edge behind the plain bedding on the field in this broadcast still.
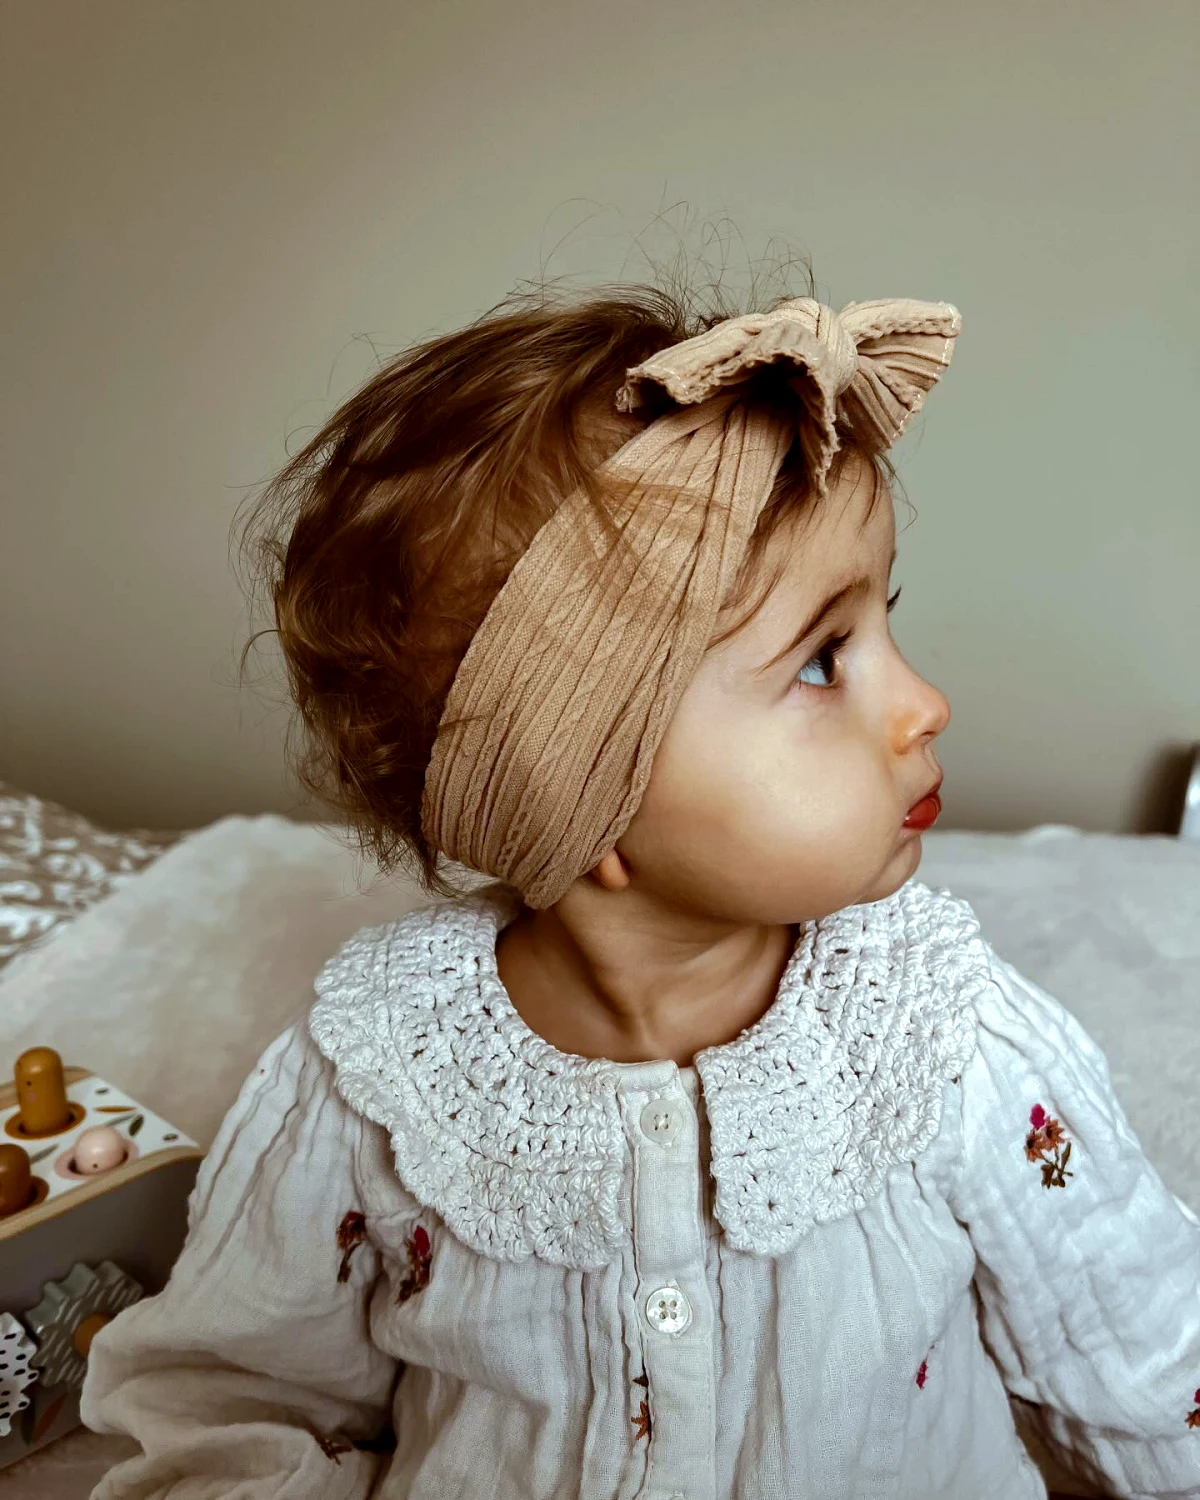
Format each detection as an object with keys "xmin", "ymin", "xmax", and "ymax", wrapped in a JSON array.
[{"xmin": 0, "ymin": 782, "xmax": 183, "ymax": 969}]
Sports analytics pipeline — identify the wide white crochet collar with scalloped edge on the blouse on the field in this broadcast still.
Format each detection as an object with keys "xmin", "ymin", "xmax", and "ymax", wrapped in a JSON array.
[{"xmin": 309, "ymin": 881, "xmax": 990, "ymax": 1269}]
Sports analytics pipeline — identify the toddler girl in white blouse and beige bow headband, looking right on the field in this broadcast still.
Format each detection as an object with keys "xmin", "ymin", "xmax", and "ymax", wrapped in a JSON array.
[{"xmin": 83, "ymin": 273, "xmax": 1200, "ymax": 1500}]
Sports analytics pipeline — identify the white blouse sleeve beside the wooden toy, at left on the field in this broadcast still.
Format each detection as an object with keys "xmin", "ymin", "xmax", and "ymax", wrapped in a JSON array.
[{"xmin": 81, "ymin": 1023, "xmax": 399, "ymax": 1500}]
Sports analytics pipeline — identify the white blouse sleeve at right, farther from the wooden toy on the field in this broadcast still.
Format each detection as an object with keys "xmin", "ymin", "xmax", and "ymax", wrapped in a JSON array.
[{"xmin": 951, "ymin": 954, "xmax": 1200, "ymax": 1500}]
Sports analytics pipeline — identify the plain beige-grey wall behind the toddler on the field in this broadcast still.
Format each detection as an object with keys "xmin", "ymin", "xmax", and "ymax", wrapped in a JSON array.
[{"xmin": 0, "ymin": 0, "xmax": 1200, "ymax": 830}]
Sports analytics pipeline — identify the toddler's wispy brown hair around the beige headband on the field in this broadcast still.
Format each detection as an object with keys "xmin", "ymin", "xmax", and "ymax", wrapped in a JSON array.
[{"xmin": 242, "ymin": 256, "xmax": 893, "ymax": 896}]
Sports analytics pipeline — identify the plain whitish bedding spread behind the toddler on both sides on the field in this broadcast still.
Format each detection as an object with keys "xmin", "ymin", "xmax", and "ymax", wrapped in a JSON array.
[{"xmin": 0, "ymin": 816, "xmax": 1200, "ymax": 1500}]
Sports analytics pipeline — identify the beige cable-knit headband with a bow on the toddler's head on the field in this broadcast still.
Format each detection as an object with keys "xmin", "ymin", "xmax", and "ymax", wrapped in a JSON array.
[{"xmin": 422, "ymin": 297, "xmax": 962, "ymax": 909}]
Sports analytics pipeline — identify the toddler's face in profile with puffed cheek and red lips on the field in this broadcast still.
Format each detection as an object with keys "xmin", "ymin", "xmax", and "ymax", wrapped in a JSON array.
[{"xmin": 617, "ymin": 459, "xmax": 950, "ymax": 924}]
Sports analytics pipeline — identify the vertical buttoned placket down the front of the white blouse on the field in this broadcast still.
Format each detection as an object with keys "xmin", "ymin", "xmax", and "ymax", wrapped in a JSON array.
[{"xmin": 621, "ymin": 1061, "xmax": 716, "ymax": 1500}]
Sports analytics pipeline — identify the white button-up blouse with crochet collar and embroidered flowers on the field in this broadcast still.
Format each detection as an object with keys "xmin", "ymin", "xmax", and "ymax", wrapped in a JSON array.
[{"xmin": 83, "ymin": 882, "xmax": 1200, "ymax": 1500}]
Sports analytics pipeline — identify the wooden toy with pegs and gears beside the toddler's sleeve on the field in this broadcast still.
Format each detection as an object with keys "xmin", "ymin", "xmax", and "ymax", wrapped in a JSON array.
[{"xmin": 0, "ymin": 1047, "xmax": 204, "ymax": 1469}]
